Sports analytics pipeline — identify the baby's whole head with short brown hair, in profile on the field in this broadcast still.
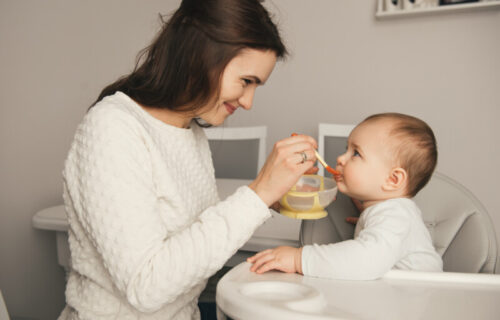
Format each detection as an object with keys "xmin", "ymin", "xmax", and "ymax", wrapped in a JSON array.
[{"xmin": 337, "ymin": 113, "xmax": 437, "ymax": 206}]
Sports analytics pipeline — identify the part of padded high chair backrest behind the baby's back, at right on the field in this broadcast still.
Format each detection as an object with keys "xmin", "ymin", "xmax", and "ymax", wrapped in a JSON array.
[{"xmin": 415, "ymin": 172, "xmax": 497, "ymax": 273}]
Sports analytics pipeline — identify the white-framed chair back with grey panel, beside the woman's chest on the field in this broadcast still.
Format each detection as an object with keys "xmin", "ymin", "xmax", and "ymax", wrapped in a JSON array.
[{"xmin": 204, "ymin": 126, "xmax": 267, "ymax": 179}]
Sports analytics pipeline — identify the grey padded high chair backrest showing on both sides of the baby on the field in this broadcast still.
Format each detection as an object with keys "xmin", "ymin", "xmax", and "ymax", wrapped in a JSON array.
[{"xmin": 300, "ymin": 172, "xmax": 497, "ymax": 273}]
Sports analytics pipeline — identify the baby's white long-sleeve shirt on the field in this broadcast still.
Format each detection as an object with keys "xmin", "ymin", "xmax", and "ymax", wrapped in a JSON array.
[{"xmin": 302, "ymin": 198, "xmax": 443, "ymax": 280}]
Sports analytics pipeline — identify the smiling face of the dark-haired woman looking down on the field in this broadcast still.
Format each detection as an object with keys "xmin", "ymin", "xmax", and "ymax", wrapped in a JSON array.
[{"xmin": 197, "ymin": 49, "xmax": 276, "ymax": 126}]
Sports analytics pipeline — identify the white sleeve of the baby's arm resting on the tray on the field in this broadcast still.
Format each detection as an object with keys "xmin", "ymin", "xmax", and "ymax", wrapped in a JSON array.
[{"xmin": 302, "ymin": 202, "xmax": 411, "ymax": 280}]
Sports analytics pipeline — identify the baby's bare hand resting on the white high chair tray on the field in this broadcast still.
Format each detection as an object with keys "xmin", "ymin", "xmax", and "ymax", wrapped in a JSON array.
[{"xmin": 247, "ymin": 246, "xmax": 302, "ymax": 273}]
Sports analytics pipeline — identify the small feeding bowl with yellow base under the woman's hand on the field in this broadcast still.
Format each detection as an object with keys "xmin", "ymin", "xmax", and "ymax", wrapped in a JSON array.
[{"xmin": 280, "ymin": 175, "xmax": 337, "ymax": 219}]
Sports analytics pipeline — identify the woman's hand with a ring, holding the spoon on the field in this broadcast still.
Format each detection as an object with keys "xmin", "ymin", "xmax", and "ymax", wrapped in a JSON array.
[{"xmin": 249, "ymin": 135, "xmax": 317, "ymax": 206}]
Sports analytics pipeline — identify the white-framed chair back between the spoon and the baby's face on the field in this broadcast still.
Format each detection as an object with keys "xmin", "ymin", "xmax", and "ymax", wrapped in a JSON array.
[{"xmin": 318, "ymin": 123, "xmax": 354, "ymax": 175}]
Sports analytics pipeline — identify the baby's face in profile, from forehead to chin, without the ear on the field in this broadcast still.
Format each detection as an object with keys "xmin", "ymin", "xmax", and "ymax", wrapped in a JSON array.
[{"xmin": 336, "ymin": 120, "xmax": 394, "ymax": 201}]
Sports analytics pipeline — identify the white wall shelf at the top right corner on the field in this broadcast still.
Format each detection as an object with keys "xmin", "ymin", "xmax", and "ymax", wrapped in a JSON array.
[{"xmin": 375, "ymin": 0, "xmax": 500, "ymax": 19}]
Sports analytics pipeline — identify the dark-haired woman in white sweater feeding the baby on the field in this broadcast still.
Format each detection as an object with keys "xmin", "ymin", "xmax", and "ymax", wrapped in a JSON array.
[{"xmin": 60, "ymin": 0, "xmax": 316, "ymax": 319}]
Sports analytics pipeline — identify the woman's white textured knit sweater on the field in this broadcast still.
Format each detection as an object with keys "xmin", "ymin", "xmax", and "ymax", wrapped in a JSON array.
[{"xmin": 59, "ymin": 92, "xmax": 270, "ymax": 320}]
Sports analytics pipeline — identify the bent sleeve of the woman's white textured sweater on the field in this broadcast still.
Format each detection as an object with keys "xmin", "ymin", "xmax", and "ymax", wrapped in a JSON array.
[{"xmin": 64, "ymin": 110, "xmax": 270, "ymax": 312}]
